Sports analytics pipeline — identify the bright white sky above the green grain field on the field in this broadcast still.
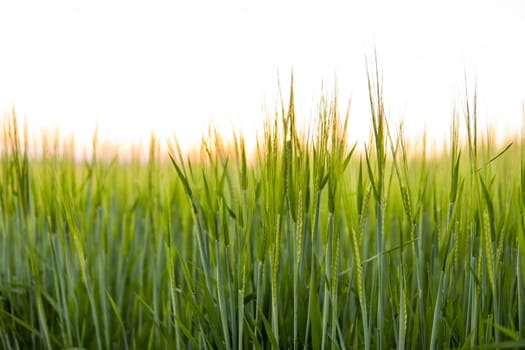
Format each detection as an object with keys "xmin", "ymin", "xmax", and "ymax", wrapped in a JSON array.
[{"xmin": 0, "ymin": 0, "xmax": 525, "ymax": 156}]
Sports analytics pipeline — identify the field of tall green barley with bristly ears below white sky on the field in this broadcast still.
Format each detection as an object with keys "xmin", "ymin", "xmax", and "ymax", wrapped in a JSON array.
[{"xmin": 0, "ymin": 72, "xmax": 525, "ymax": 350}]
